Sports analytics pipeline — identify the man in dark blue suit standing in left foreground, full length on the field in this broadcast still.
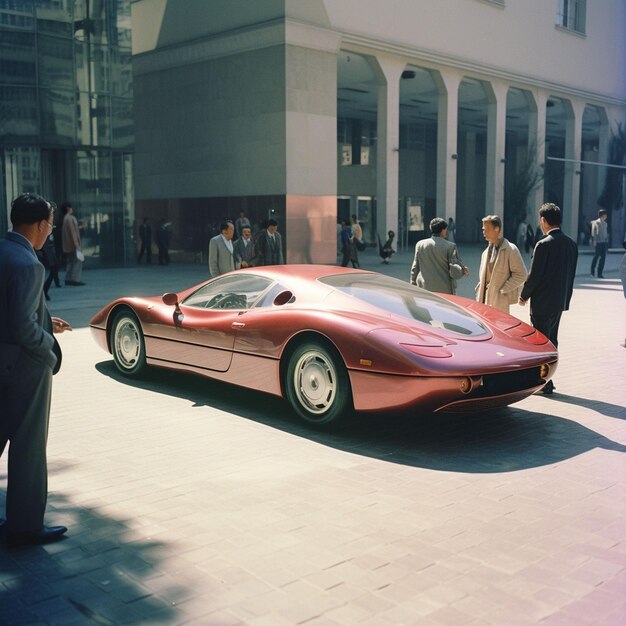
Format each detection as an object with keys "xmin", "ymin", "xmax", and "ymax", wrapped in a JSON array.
[{"xmin": 0, "ymin": 193, "xmax": 71, "ymax": 546}]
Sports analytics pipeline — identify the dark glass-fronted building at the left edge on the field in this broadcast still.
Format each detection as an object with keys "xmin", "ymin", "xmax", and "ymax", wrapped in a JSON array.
[{"xmin": 0, "ymin": 0, "xmax": 135, "ymax": 267}]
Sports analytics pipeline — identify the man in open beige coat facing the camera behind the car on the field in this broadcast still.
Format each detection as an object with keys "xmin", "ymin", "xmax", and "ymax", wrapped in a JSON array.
[{"xmin": 476, "ymin": 215, "xmax": 528, "ymax": 313}]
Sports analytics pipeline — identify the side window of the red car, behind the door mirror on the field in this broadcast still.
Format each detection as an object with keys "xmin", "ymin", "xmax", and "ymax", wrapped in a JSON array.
[{"xmin": 183, "ymin": 273, "xmax": 272, "ymax": 310}]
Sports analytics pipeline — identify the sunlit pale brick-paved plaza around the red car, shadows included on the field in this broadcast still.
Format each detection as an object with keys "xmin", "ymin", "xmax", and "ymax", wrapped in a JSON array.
[{"xmin": 0, "ymin": 247, "xmax": 626, "ymax": 626}]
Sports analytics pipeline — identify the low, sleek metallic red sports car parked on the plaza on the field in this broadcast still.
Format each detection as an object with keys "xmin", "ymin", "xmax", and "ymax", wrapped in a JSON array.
[{"xmin": 90, "ymin": 265, "xmax": 558, "ymax": 425}]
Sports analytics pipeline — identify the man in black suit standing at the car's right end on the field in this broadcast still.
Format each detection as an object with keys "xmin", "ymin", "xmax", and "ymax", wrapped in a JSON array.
[{"xmin": 519, "ymin": 203, "xmax": 578, "ymax": 394}]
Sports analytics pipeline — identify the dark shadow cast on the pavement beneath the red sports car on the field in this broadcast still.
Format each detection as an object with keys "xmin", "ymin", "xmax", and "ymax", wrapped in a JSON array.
[{"xmin": 96, "ymin": 361, "xmax": 626, "ymax": 473}]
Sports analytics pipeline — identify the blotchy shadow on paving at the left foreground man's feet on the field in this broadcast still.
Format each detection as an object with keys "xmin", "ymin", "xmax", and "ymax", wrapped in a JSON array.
[{"xmin": 0, "ymin": 482, "xmax": 178, "ymax": 626}]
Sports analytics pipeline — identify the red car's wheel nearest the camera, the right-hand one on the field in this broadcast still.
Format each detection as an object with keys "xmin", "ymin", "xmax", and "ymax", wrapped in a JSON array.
[{"xmin": 285, "ymin": 340, "xmax": 352, "ymax": 426}]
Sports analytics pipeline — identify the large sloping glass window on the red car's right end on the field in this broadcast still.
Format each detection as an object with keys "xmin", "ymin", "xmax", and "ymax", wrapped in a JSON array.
[{"xmin": 320, "ymin": 274, "xmax": 489, "ymax": 337}]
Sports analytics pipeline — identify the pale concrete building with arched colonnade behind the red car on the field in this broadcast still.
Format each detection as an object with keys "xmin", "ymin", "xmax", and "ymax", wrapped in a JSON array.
[{"xmin": 132, "ymin": 0, "xmax": 626, "ymax": 263}]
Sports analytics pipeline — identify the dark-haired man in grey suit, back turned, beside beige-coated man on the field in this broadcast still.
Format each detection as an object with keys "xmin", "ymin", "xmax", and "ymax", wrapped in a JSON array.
[{"xmin": 410, "ymin": 217, "xmax": 469, "ymax": 294}]
